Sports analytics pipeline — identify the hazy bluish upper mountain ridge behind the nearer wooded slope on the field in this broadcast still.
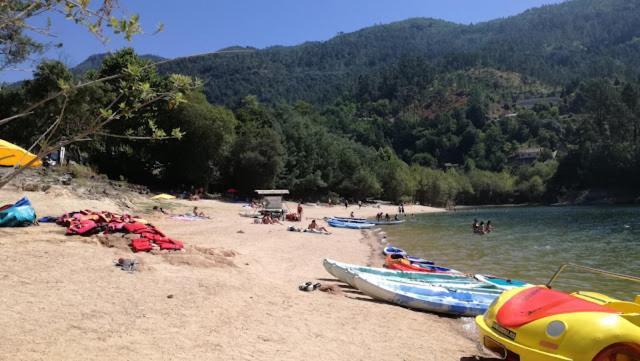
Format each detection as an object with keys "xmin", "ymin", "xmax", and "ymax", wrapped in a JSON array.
[{"xmin": 77, "ymin": 0, "xmax": 640, "ymax": 105}]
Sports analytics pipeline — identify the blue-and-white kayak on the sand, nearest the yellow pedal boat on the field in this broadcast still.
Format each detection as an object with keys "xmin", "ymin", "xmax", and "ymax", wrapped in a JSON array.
[{"xmin": 353, "ymin": 273, "xmax": 500, "ymax": 316}]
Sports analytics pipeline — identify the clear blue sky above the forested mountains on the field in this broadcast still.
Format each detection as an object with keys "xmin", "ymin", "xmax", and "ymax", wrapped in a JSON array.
[{"xmin": 0, "ymin": 0, "xmax": 562, "ymax": 81}]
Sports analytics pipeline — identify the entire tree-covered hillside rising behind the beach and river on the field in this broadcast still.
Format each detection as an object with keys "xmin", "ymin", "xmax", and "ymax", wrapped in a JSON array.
[{"xmin": 0, "ymin": 0, "xmax": 640, "ymax": 205}]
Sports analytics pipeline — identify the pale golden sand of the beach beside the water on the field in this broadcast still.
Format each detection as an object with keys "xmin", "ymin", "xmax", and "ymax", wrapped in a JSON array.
[{"xmin": 0, "ymin": 189, "xmax": 490, "ymax": 361}]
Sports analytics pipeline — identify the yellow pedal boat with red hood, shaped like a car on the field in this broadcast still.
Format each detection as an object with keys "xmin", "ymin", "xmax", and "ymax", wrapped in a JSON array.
[{"xmin": 476, "ymin": 264, "xmax": 640, "ymax": 361}]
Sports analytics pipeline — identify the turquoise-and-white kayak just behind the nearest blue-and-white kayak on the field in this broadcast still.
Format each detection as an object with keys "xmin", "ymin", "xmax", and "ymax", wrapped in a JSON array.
[{"xmin": 322, "ymin": 259, "xmax": 470, "ymax": 286}]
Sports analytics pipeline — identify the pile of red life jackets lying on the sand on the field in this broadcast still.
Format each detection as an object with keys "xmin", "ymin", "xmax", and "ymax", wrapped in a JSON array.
[{"xmin": 56, "ymin": 210, "xmax": 184, "ymax": 252}]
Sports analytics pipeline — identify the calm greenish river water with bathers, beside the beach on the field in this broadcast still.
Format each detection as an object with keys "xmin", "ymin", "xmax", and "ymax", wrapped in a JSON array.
[{"xmin": 385, "ymin": 206, "xmax": 640, "ymax": 299}]
